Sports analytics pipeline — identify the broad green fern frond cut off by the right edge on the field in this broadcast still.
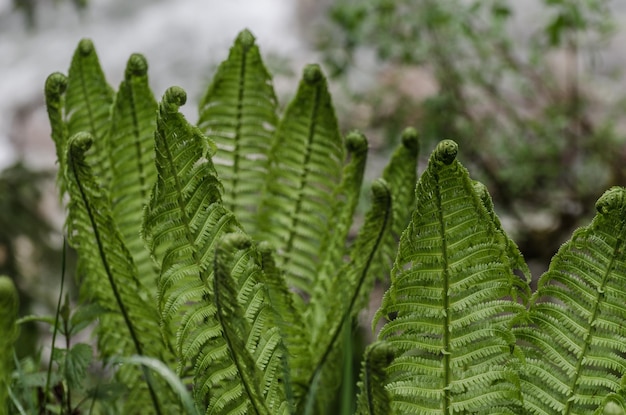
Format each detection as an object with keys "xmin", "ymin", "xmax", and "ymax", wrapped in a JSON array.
[{"xmin": 516, "ymin": 187, "xmax": 626, "ymax": 414}]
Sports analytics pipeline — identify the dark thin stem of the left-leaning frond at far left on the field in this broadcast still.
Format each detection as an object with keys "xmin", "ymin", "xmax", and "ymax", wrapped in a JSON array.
[{"xmin": 71, "ymin": 158, "xmax": 162, "ymax": 415}]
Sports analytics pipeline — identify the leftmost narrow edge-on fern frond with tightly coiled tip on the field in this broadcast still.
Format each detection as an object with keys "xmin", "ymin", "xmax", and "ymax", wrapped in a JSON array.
[{"xmin": 45, "ymin": 72, "xmax": 68, "ymax": 195}]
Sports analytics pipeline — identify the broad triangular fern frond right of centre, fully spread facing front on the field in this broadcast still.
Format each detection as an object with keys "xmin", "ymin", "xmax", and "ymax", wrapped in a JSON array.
[{"xmin": 374, "ymin": 140, "xmax": 524, "ymax": 415}]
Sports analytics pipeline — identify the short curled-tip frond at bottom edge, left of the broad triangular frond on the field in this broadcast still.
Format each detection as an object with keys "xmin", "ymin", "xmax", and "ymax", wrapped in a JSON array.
[{"xmin": 356, "ymin": 342, "xmax": 394, "ymax": 415}]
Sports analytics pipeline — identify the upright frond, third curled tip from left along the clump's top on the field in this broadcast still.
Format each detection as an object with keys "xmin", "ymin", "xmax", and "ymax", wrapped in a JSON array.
[{"xmin": 110, "ymin": 54, "xmax": 157, "ymax": 300}]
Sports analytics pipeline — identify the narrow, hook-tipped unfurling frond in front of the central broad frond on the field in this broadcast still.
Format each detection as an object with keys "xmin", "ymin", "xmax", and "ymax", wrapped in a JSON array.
[{"xmin": 213, "ymin": 233, "xmax": 270, "ymax": 415}]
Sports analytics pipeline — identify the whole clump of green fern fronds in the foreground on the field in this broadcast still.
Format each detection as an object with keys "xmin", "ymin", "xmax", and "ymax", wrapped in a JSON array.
[{"xmin": 35, "ymin": 26, "xmax": 626, "ymax": 415}]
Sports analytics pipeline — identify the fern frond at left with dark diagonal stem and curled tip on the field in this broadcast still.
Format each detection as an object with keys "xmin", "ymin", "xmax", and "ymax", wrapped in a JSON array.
[{"xmin": 65, "ymin": 133, "xmax": 167, "ymax": 413}]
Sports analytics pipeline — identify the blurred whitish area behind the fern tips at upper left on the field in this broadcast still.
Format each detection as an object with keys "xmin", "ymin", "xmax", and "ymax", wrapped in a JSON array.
[{"xmin": 0, "ymin": 0, "xmax": 315, "ymax": 170}]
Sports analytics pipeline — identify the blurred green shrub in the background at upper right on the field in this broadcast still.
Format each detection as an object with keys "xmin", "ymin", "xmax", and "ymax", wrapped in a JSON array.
[{"xmin": 319, "ymin": 0, "xmax": 626, "ymax": 262}]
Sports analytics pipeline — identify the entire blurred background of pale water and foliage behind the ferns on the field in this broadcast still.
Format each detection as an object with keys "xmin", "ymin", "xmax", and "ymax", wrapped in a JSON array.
[{"xmin": 0, "ymin": 0, "xmax": 626, "ymax": 354}]
